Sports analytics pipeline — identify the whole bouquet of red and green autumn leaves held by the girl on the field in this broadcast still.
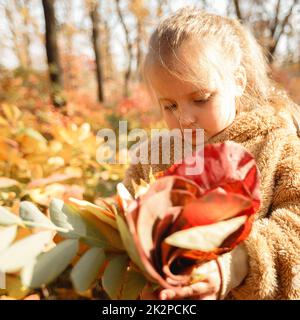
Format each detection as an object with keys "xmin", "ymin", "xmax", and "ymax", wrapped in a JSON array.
[{"xmin": 0, "ymin": 142, "xmax": 260, "ymax": 299}]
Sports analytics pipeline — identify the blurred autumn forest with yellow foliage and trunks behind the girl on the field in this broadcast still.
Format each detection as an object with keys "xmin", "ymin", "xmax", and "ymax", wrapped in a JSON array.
[{"xmin": 0, "ymin": 0, "xmax": 300, "ymax": 298}]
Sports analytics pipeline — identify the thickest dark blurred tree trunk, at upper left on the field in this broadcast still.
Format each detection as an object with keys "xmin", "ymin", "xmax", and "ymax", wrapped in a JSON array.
[{"xmin": 42, "ymin": 0, "xmax": 66, "ymax": 107}]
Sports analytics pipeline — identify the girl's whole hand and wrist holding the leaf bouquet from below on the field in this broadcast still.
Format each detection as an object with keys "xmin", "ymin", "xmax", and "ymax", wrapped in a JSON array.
[{"xmin": 141, "ymin": 260, "xmax": 221, "ymax": 300}]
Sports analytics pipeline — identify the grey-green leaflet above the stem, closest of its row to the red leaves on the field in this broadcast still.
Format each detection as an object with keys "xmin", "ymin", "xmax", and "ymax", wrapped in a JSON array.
[{"xmin": 49, "ymin": 199, "xmax": 110, "ymax": 248}]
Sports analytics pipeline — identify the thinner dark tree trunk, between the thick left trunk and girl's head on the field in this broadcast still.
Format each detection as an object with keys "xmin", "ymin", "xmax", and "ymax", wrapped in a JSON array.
[{"xmin": 90, "ymin": 0, "xmax": 104, "ymax": 102}]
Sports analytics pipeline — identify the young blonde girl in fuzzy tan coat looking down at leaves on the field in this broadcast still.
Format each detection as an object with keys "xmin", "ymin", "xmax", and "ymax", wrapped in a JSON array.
[{"xmin": 123, "ymin": 7, "xmax": 300, "ymax": 299}]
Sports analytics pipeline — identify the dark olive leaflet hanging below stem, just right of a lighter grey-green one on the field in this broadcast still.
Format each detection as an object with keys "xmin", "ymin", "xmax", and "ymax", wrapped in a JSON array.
[{"xmin": 102, "ymin": 255, "xmax": 128, "ymax": 300}]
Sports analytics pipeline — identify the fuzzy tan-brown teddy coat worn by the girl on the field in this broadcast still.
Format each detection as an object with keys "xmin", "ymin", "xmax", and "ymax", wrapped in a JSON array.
[{"xmin": 123, "ymin": 107, "xmax": 300, "ymax": 299}]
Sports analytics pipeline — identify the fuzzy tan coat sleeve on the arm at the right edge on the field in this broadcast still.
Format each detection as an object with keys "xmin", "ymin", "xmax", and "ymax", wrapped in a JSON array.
[{"xmin": 227, "ymin": 139, "xmax": 300, "ymax": 299}]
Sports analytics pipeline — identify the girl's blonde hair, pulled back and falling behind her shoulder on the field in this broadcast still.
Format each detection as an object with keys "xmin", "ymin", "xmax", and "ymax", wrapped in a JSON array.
[{"xmin": 142, "ymin": 7, "xmax": 300, "ymax": 121}]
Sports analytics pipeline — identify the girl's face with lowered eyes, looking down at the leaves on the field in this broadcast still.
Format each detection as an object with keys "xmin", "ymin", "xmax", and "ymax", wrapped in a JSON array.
[{"xmin": 149, "ymin": 45, "xmax": 240, "ymax": 144}]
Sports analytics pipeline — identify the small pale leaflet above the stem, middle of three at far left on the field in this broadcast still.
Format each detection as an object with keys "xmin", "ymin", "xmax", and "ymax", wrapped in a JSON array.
[{"xmin": 20, "ymin": 201, "xmax": 67, "ymax": 231}]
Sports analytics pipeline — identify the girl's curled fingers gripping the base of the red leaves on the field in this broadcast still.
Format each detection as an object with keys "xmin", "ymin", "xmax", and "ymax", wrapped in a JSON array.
[{"xmin": 159, "ymin": 282, "xmax": 211, "ymax": 300}]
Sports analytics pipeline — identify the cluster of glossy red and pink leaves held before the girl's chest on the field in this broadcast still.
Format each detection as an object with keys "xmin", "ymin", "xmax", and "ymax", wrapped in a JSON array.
[{"xmin": 125, "ymin": 141, "xmax": 260, "ymax": 291}]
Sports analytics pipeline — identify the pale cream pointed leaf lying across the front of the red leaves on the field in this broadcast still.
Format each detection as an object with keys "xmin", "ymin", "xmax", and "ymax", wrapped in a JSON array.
[{"xmin": 165, "ymin": 216, "xmax": 247, "ymax": 252}]
